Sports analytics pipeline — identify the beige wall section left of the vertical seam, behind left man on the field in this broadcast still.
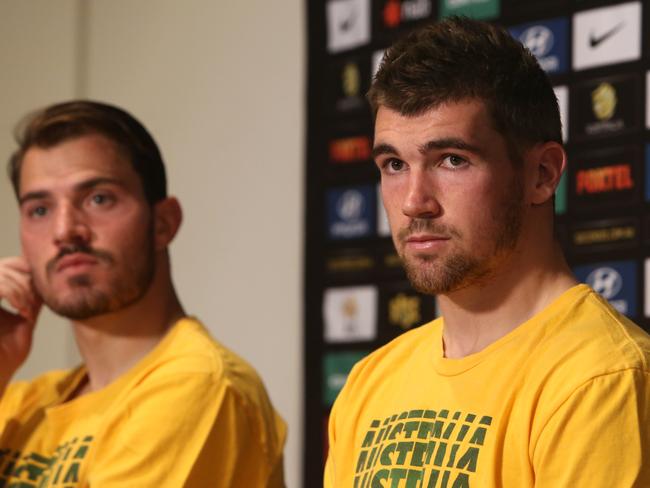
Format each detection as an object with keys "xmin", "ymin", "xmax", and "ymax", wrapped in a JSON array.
[{"xmin": 0, "ymin": 0, "xmax": 78, "ymax": 378}]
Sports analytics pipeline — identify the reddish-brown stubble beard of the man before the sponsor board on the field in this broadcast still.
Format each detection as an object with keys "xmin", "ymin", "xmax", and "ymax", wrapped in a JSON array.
[{"xmin": 396, "ymin": 177, "xmax": 523, "ymax": 295}]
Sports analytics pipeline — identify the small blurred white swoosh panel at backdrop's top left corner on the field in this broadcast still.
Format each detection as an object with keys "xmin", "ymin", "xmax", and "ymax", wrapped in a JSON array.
[{"xmin": 327, "ymin": 0, "xmax": 370, "ymax": 53}]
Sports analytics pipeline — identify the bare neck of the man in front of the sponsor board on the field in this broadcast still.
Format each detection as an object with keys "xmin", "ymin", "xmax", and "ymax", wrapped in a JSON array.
[{"xmin": 438, "ymin": 238, "xmax": 577, "ymax": 358}]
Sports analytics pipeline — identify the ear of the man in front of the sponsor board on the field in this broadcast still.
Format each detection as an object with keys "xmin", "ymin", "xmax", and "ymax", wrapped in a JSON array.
[{"xmin": 528, "ymin": 141, "xmax": 567, "ymax": 205}]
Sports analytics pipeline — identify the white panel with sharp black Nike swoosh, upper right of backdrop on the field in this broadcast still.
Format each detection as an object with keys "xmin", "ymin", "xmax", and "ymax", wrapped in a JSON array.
[{"xmin": 573, "ymin": 2, "xmax": 641, "ymax": 70}]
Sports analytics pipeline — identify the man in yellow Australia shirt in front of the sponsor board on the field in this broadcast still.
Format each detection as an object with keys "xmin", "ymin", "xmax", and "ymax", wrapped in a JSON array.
[{"xmin": 325, "ymin": 18, "xmax": 650, "ymax": 488}]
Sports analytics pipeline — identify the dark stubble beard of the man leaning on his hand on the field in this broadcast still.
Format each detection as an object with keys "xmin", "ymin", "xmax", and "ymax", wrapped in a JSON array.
[{"xmin": 35, "ymin": 229, "xmax": 155, "ymax": 320}]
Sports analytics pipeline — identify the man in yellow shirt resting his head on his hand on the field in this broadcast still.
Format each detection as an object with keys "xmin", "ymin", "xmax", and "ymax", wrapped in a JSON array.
[{"xmin": 0, "ymin": 101, "xmax": 286, "ymax": 488}]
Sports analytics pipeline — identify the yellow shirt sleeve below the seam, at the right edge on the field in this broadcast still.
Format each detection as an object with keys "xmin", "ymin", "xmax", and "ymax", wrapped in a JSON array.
[{"xmin": 531, "ymin": 368, "xmax": 650, "ymax": 488}]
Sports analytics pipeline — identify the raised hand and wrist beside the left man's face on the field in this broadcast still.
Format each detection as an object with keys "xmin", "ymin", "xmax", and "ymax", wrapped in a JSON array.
[{"xmin": 0, "ymin": 257, "xmax": 42, "ymax": 391}]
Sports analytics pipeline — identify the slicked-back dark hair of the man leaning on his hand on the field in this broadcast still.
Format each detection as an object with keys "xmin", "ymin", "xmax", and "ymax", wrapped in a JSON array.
[{"xmin": 7, "ymin": 100, "xmax": 167, "ymax": 205}]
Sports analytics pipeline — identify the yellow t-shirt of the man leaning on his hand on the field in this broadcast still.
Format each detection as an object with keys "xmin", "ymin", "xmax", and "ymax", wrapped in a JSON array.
[{"xmin": 0, "ymin": 318, "xmax": 286, "ymax": 488}]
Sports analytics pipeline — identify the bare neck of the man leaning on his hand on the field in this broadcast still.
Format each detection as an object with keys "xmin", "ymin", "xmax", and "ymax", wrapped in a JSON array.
[{"xmin": 72, "ymin": 270, "xmax": 185, "ymax": 393}]
